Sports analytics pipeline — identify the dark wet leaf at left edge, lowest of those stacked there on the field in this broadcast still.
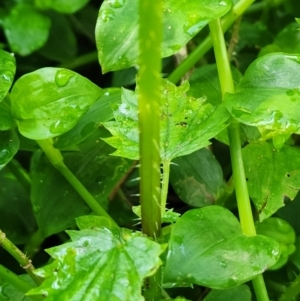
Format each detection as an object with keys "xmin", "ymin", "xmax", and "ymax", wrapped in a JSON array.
[{"xmin": 0, "ymin": 130, "xmax": 20, "ymax": 170}]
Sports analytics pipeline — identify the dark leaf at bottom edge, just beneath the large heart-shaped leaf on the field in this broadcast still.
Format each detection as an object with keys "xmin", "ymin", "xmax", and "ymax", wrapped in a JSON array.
[{"xmin": 203, "ymin": 284, "xmax": 252, "ymax": 301}]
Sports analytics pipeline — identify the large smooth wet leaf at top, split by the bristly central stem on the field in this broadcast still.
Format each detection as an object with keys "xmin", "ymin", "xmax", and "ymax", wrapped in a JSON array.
[{"xmin": 96, "ymin": 0, "xmax": 231, "ymax": 72}]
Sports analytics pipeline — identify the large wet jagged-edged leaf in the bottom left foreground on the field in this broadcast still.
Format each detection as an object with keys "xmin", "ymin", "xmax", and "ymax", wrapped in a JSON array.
[{"xmin": 29, "ymin": 228, "xmax": 165, "ymax": 301}]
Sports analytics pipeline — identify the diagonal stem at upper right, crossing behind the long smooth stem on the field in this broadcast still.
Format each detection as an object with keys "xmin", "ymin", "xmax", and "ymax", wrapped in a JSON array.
[{"xmin": 168, "ymin": 0, "xmax": 255, "ymax": 83}]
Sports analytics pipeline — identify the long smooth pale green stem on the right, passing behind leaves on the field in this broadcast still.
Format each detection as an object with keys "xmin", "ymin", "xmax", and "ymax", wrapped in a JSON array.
[{"xmin": 209, "ymin": 19, "xmax": 269, "ymax": 301}]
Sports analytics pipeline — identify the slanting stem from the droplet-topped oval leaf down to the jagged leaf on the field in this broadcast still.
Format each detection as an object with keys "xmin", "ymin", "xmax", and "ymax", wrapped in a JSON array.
[{"xmin": 37, "ymin": 139, "xmax": 118, "ymax": 227}]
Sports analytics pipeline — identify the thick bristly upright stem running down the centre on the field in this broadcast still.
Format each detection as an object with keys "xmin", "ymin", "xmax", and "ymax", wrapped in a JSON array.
[{"xmin": 137, "ymin": 0, "xmax": 163, "ymax": 301}]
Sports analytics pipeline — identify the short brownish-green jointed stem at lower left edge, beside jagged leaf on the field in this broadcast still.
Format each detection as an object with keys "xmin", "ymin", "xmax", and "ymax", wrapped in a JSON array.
[{"xmin": 0, "ymin": 230, "xmax": 43, "ymax": 285}]
